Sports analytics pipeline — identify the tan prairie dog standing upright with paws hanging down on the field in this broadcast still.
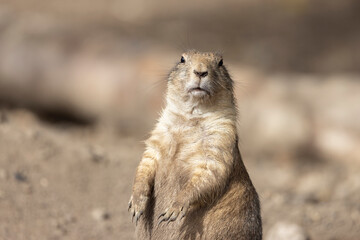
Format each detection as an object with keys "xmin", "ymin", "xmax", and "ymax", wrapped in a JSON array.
[{"xmin": 129, "ymin": 51, "xmax": 262, "ymax": 240}]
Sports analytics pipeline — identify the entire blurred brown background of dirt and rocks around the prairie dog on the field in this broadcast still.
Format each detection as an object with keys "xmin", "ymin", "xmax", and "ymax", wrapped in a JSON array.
[{"xmin": 0, "ymin": 0, "xmax": 360, "ymax": 240}]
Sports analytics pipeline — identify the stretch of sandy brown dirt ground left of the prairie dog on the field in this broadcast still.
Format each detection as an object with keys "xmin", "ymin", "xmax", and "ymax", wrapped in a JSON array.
[{"xmin": 0, "ymin": 110, "xmax": 142, "ymax": 240}]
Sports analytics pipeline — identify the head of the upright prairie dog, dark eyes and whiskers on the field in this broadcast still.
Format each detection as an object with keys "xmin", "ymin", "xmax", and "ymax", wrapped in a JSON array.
[{"xmin": 168, "ymin": 51, "xmax": 233, "ymax": 108}]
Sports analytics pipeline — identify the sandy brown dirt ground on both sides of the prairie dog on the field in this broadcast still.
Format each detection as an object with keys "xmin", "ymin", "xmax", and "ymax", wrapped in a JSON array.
[{"xmin": 0, "ymin": 108, "xmax": 360, "ymax": 240}]
